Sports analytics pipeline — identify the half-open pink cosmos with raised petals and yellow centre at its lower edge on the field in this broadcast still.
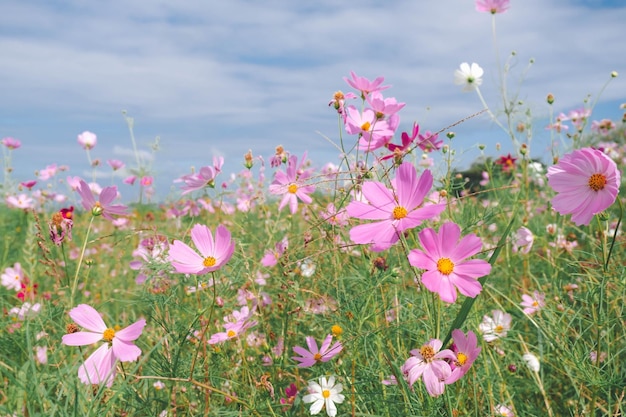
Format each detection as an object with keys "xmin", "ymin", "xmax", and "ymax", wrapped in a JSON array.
[{"xmin": 168, "ymin": 224, "xmax": 235, "ymax": 275}]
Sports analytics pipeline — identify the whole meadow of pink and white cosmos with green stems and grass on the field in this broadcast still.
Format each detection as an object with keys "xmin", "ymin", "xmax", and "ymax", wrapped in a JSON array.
[{"xmin": 0, "ymin": 0, "xmax": 626, "ymax": 416}]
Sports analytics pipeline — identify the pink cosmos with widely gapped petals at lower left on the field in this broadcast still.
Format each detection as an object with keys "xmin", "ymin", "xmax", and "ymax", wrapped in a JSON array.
[{"xmin": 62, "ymin": 304, "xmax": 146, "ymax": 386}]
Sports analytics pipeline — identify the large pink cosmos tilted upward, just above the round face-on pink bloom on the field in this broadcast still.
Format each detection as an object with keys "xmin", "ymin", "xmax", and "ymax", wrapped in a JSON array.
[{"xmin": 346, "ymin": 162, "xmax": 445, "ymax": 252}]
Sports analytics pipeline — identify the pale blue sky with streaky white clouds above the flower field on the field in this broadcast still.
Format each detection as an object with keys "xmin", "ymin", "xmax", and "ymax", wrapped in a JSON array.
[{"xmin": 0, "ymin": 0, "xmax": 626, "ymax": 202}]
